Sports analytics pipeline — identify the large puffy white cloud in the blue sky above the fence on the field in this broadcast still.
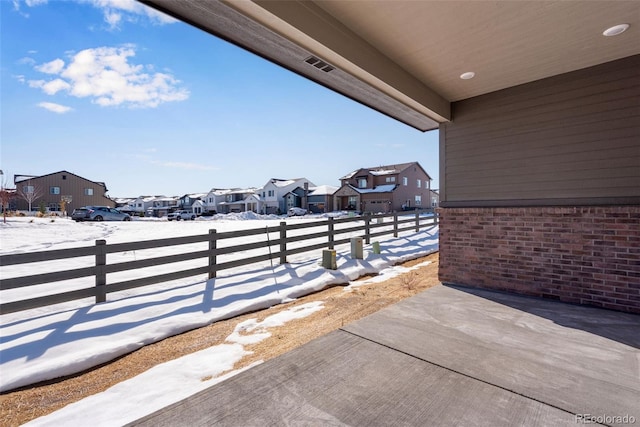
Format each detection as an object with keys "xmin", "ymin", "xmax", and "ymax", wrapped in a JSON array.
[{"xmin": 29, "ymin": 46, "xmax": 189, "ymax": 108}]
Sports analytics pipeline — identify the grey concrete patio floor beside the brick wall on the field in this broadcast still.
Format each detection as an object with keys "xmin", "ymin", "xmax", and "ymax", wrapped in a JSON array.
[{"xmin": 132, "ymin": 285, "xmax": 640, "ymax": 427}]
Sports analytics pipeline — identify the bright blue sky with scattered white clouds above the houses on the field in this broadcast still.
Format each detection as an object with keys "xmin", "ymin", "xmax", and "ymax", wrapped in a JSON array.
[{"xmin": 0, "ymin": 0, "xmax": 438, "ymax": 197}]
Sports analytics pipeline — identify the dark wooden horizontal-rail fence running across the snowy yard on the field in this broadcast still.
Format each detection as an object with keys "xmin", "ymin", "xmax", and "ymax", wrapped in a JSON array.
[{"xmin": 0, "ymin": 210, "xmax": 437, "ymax": 314}]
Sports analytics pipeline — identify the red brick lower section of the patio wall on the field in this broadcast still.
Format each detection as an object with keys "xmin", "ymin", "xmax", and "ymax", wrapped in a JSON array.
[{"xmin": 439, "ymin": 206, "xmax": 640, "ymax": 313}]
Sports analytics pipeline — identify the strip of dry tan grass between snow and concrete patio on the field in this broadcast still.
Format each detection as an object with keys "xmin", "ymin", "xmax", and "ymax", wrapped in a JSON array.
[{"xmin": 0, "ymin": 253, "xmax": 439, "ymax": 427}]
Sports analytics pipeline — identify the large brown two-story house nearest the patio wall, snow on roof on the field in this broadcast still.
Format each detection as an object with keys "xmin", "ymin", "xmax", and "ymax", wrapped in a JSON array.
[{"xmin": 334, "ymin": 162, "xmax": 431, "ymax": 212}]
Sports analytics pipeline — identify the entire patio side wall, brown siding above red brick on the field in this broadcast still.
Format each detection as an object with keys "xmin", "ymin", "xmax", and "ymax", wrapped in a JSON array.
[{"xmin": 439, "ymin": 56, "xmax": 640, "ymax": 313}]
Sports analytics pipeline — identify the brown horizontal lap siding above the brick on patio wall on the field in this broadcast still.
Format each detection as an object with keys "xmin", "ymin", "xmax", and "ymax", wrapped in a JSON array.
[{"xmin": 440, "ymin": 56, "xmax": 640, "ymax": 207}]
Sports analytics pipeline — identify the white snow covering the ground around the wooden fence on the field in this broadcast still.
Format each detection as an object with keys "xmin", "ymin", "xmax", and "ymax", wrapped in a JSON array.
[{"xmin": 0, "ymin": 214, "xmax": 438, "ymax": 426}]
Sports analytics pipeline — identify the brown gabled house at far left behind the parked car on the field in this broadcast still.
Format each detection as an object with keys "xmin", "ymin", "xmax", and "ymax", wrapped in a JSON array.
[{"xmin": 13, "ymin": 170, "xmax": 116, "ymax": 214}]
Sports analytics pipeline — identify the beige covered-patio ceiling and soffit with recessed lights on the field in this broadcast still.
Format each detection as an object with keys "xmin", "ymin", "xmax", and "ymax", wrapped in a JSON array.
[{"xmin": 142, "ymin": 0, "xmax": 640, "ymax": 130}]
